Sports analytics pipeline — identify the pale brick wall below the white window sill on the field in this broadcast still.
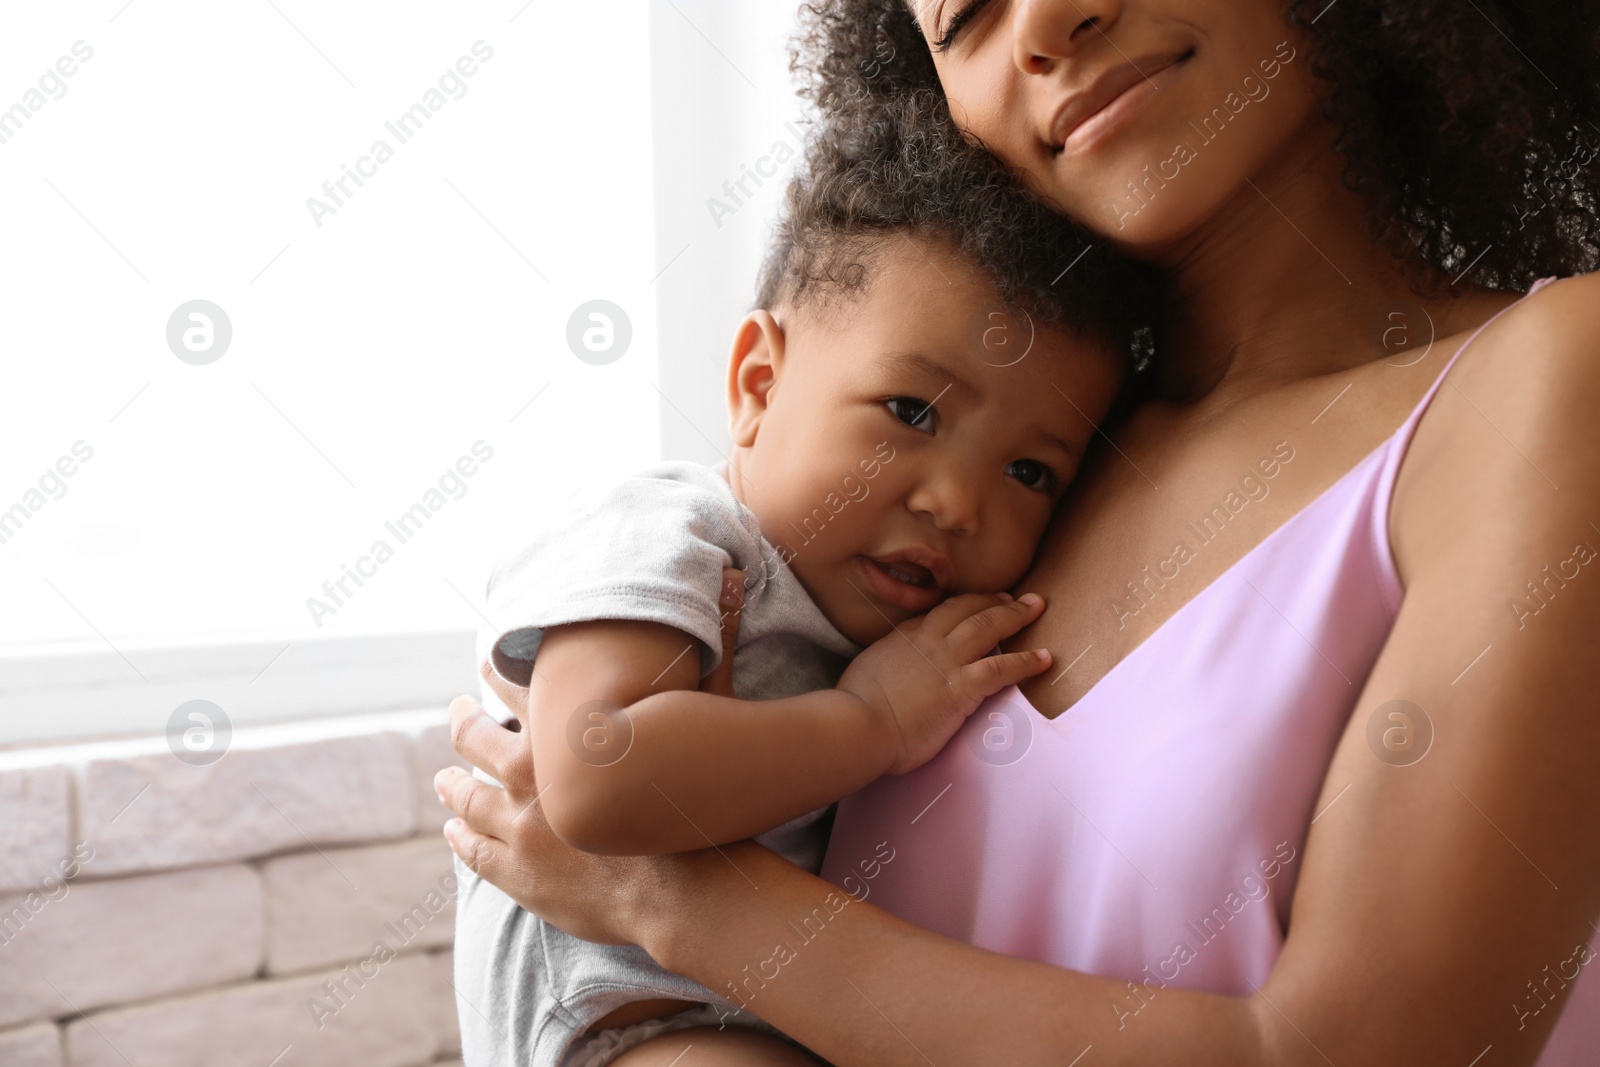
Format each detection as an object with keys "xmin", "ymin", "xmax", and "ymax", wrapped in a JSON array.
[{"xmin": 0, "ymin": 710, "xmax": 470, "ymax": 1067}]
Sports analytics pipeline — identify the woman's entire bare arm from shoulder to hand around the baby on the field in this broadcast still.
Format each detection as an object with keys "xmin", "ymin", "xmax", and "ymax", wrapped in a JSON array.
[{"xmin": 440, "ymin": 278, "xmax": 1600, "ymax": 1067}]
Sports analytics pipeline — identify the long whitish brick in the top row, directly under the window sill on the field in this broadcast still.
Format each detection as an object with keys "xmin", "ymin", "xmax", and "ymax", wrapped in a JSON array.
[{"xmin": 80, "ymin": 731, "xmax": 416, "ymax": 875}]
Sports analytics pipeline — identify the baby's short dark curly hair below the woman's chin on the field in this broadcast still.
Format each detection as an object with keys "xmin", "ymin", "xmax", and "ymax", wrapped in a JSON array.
[{"xmin": 757, "ymin": 91, "xmax": 1154, "ymax": 356}]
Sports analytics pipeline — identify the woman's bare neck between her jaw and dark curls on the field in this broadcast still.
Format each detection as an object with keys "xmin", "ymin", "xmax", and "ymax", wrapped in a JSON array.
[{"xmin": 1154, "ymin": 120, "xmax": 1507, "ymax": 403}]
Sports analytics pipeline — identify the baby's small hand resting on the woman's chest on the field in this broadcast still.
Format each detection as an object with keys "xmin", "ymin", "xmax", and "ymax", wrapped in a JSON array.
[{"xmin": 838, "ymin": 593, "xmax": 1050, "ymax": 774}]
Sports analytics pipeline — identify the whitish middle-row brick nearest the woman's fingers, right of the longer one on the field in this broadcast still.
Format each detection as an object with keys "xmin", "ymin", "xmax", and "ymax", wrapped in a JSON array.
[{"xmin": 261, "ymin": 833, "xmax": 456, "ymax": 974}]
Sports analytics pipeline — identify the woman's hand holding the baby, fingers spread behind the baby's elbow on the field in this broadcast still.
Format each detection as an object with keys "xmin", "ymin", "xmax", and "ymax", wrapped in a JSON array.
[{"xmin": 434, "ymin": 569, "xmax": 744, "ymax": 944}]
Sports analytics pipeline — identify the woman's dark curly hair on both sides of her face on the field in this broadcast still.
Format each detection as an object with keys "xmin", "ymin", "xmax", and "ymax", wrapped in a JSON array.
[{"xmin": 792, "ymin": 0, "xmax": 1600, "ymax": 290}]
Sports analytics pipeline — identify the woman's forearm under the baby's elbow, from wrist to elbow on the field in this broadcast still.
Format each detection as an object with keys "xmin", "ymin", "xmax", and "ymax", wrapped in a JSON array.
[{"xmin": 637, "ymin": 843, "xmax": 1273, "ymax": 1067}]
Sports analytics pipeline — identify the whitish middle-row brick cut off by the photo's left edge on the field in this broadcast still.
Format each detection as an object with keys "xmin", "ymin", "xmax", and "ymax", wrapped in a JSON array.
[{"xmin": 0, "ymin": 865, "xmax": 261, "ymax": 1030}]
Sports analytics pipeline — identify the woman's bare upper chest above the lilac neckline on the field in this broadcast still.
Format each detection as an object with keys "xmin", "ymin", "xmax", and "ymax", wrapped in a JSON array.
[{"xmin": 1006, "ymin": 358, "xmax": 1426, "ymax": 715}]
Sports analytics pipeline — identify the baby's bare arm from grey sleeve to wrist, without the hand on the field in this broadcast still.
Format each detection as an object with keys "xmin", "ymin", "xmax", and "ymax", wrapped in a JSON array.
[{"xmin": 528, "ymin": 621, "xmax": 894, "ymax": 856}]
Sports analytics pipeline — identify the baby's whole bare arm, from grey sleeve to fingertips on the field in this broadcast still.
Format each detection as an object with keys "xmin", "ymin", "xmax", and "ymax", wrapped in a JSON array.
[{"xmin": 528, "ymin": 597, "xmax": 1048, "ymax": 856}]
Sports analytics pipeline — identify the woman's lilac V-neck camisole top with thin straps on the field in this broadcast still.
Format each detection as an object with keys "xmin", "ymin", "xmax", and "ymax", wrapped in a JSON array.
[{"xmin": 822, "ymin": 278, "xmax": 1600, "ymax": 1067}]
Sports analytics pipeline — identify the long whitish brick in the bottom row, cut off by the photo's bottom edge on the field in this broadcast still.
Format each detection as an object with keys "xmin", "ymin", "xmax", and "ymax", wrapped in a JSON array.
[{"xmin": 67, "ymin": 953, "xmax": 437, "ymax": 1067}]
